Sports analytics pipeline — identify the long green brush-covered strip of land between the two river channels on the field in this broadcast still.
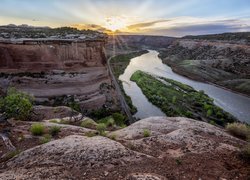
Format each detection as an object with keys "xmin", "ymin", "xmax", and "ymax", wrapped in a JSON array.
[{"xmin": 131, "ymin": 71, "xmax": 236, "ymax": 126}]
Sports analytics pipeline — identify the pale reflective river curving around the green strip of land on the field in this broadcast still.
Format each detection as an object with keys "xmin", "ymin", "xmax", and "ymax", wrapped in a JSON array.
[{"xmin": 119, "ymin": 50, "xmax": 250, "ymax": 124}]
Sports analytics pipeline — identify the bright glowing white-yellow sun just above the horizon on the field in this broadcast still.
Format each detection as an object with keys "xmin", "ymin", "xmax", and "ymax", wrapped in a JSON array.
[{"xmin": 105, "ymin": 16, "xmax": 127, "ymax": 32}]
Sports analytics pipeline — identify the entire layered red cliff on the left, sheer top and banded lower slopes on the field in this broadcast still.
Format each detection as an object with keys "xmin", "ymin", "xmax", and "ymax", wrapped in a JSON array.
[{"xmin": 0, "ymin": 39, "xmax": 117, "ymax": 110}]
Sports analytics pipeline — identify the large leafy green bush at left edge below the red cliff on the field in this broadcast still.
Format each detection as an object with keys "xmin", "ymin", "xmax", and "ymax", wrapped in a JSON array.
[{"xmin": 0, "ymin": 88, "xmax": 33, "ymax": 120}]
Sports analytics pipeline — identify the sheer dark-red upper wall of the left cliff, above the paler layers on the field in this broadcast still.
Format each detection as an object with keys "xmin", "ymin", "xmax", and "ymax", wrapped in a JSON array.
[{"xmin": 0, "ymin": 41, "xmax": 106, "ymax": 72}]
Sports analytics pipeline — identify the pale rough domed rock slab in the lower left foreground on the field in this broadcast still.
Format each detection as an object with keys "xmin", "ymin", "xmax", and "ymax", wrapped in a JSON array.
[{"xmin": 0, "ymin": 135, "xmax": 145, "ymax": 179}]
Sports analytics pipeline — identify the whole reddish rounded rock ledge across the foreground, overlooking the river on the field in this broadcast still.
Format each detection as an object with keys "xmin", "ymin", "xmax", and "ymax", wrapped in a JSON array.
[{"xmin": 0, "ymin": 117, "xmax": 250, "ymax": 179}]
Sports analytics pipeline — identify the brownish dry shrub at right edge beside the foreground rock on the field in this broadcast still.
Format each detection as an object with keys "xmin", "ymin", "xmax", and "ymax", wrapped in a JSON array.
[{"xmin": 226, "ymin": 123, "xmax": 250, "ymax": 140}]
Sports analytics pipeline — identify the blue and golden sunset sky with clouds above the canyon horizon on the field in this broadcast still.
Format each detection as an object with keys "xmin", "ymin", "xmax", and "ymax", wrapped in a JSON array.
[{"xmin": 0, "ymin": 0, "xmax": 250, "ymax": 37}]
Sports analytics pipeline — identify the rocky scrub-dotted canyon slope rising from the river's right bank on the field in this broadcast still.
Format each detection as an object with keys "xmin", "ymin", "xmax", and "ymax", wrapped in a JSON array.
[{"xmin": 160, "ymin": 39, "xmax": 250, "ymax": 95}]
